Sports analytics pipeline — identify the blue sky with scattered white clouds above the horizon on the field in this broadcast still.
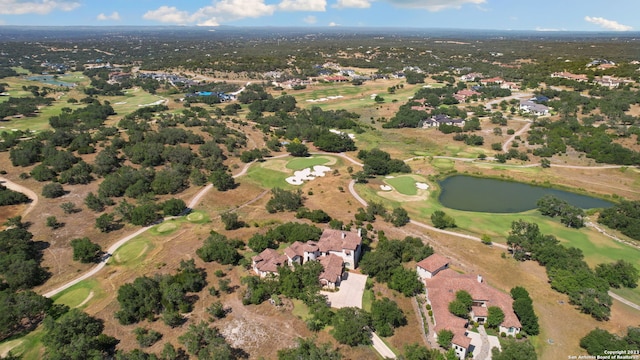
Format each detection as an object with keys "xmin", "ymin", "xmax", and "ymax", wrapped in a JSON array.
[{"xmin": 0, "ymin": 0, "xmax": 640, "ymax": 31}]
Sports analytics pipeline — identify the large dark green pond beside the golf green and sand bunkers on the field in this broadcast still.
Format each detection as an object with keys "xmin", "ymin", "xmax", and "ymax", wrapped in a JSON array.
[{"xmin": 439, "ymin": 175, "xmax": 613, "ymax": 213}]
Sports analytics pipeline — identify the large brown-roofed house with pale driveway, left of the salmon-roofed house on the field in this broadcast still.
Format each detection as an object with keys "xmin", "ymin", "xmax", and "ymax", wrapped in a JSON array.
[{"xmin": 252, "ymin": 229, "xmax": 362, "ymax": 289}]
